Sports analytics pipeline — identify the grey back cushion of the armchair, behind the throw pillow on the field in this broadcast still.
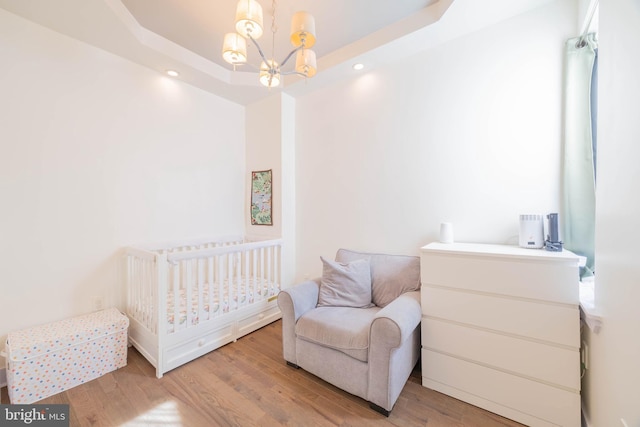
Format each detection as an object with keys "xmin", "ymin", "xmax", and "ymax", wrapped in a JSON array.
[{"xmin": 336, "ymin": 249, "xmax": 420, "ymax": 307}]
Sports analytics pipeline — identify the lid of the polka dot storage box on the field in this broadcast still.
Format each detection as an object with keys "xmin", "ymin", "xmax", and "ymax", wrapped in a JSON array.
[{"xmin": 7, "ymin": 308, "xmax": 129, "ymax": 361}]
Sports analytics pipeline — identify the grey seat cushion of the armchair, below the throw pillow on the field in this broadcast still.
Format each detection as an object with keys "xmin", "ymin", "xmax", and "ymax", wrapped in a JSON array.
[{"xmin": 295, "ymin": 307, "xmax": 381, "ymax": 362}]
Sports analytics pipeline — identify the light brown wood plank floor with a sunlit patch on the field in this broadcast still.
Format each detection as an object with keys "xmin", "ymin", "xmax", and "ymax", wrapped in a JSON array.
[{"xmin": 1, "ymin": 321, "xmax": 520, "ymax": 427}]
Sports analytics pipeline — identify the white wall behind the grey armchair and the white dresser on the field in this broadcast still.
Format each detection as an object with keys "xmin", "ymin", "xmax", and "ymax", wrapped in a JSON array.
[{"xmin": 296, "ymin": 0, "xmax": 576, "ymax": 278}]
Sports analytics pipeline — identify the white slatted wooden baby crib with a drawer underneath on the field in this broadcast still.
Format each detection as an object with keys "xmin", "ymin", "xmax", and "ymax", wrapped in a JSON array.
[{"xmin": 126, "ymin": 238, "xmax": 282, "ymax": 378}]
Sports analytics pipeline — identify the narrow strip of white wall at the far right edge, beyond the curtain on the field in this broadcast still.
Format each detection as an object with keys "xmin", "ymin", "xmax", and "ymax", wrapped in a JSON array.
[{"xmin": 583, "ymin": 0, "xmax": 640, "ymax": 427}]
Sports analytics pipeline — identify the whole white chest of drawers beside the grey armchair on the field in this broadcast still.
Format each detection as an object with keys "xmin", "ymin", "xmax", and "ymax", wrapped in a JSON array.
[{"xmin": 421, "ymin": 243, "xmax": 580, "ymax": 427}]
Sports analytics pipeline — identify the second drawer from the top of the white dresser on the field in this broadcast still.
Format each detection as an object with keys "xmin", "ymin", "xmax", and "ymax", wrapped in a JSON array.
[{"xmin": 420, "ymin": 285, "xmax": 580, "ymax": 349}]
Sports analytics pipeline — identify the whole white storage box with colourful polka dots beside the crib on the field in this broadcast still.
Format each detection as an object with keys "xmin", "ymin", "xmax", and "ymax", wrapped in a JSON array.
[{"xmin": 6, "ymin": 308, "xmax": 129, "ymax": 404}]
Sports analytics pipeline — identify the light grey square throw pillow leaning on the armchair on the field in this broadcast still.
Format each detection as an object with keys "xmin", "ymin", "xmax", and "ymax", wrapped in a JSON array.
[{"xmin": 318, "ymin": 257, "xmax": 373, "ymax": 308}]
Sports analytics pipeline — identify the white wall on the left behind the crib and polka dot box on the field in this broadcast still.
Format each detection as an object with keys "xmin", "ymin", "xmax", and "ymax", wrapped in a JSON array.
[{"xmin": 0, "ymin": 9, "xmax": 245, "ymax": 339}]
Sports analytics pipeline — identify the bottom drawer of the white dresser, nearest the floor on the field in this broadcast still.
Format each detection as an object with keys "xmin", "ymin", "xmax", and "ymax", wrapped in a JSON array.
[{"xmin": 422, "ymin": 350, "xmax": 580, "ymax": 427}]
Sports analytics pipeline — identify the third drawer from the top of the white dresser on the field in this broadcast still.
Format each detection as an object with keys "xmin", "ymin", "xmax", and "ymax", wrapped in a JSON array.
[{"xmin": 422, "ymin": 318, "xmax": 580, "ymax": 393}]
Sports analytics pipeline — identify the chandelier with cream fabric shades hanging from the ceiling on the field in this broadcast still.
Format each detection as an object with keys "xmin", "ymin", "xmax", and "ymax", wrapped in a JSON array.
[{"xmin": 222, "ymin": 0, "xmax": 316, "ymax": 87}]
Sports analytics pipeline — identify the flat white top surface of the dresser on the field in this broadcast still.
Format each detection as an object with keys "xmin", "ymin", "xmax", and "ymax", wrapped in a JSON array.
[{"xmin": 420, "ymin": 242, "xmax": 578, "ymax": 262}]
